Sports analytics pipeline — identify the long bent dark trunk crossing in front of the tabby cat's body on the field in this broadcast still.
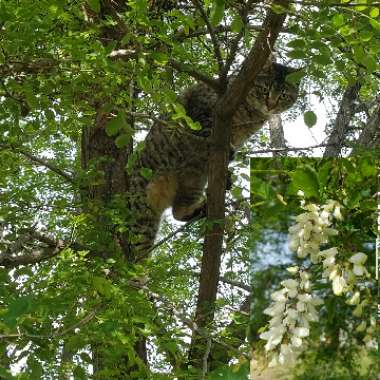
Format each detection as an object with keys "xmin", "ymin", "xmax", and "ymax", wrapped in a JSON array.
[{"xmin": 189, "ymin": 0, "xmax": 288, "ymax": 373}]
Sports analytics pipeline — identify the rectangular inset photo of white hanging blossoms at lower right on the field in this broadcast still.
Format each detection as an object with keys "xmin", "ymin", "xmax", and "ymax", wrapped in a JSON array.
[{"xmin": 248, "ymin": 154, "xmax": 379, "ymax": 380}]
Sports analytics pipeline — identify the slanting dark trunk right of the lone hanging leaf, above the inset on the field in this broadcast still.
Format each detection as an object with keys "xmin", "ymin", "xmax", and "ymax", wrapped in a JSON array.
[{"xmin": 323, "ymin": 82, "xmax": 361, "ymax": 157}]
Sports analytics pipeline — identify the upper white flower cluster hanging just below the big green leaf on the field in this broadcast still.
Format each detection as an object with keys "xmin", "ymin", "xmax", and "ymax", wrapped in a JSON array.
[{"xmin": 289, "ymin": 200, "xmax": 342, "ymax": 264}]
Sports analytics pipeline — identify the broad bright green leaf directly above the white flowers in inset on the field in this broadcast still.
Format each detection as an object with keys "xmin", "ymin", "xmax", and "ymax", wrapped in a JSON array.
[{"xmin": 290, "ymin": 165, "xmax": 319, "ymax": 198}]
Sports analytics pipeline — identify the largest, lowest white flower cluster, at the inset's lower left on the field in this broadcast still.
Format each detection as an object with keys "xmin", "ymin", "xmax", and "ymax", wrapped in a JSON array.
[{"xmin": 260, "ymin": 267, "xmax": 323, "ymax": 367}]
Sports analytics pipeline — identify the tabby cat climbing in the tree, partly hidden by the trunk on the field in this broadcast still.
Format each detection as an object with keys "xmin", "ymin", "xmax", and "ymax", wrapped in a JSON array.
[{"xmin": 130, "ymin": 63, "xmax": 298, "ymax": 259}]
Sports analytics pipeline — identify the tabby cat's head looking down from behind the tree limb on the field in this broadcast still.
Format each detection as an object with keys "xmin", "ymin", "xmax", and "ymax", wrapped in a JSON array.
[{"xmin": 247, "ymin": 62, "xmax": 300, "ymax": 116}]
